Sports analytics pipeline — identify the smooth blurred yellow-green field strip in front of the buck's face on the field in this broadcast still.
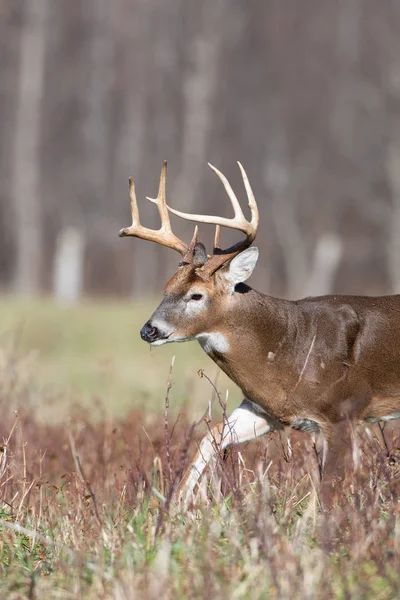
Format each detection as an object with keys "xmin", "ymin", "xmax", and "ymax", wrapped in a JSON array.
[{"xmin": 0, "ymin": 299, "xmax": 236, "ymax": 420}]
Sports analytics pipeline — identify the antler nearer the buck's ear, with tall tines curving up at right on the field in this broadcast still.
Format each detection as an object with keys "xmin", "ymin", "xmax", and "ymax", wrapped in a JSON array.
[{"xmin": 167, "ymin": 162, "xmax": 259, "ymax": 277}]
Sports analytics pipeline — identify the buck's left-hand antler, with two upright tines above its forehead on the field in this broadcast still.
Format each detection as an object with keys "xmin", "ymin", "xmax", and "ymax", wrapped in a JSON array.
[{"xmin": 119, "ymin": 160, "xmax": 191, "ymax": 262}]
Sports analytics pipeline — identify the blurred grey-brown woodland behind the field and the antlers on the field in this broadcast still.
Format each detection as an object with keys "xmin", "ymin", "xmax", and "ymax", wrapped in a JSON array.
[{"xmin": 0, "ymin": 0, "xmax": 400, "ymax": 297}]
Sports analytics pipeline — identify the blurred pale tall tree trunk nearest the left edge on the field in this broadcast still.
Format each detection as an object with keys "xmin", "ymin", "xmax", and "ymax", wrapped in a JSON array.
[{"xmin": 12, "ymin": 0, "xmax": 49, "ymax": 294}]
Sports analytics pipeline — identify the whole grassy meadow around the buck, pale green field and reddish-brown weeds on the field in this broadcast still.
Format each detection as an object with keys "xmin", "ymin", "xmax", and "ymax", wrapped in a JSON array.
[{"xmin": 0, "ymin": 298, "xmax": 400, "ymax": 600}]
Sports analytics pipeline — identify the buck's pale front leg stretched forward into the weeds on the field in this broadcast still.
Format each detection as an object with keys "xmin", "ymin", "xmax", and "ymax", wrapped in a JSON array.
[{"xmin": 178, "ymin": 399, "xmax": 272, "ymax": 506}]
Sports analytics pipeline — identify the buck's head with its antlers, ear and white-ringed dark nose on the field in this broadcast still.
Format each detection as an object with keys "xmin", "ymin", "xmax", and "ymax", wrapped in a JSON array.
[{"xmin": 120, "ymin": 162, "xmax": 259, "ymax": 346}]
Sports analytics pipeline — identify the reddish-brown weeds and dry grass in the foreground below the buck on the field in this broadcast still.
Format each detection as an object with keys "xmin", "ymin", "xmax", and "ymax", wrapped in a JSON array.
[{"xmin": 0, "ymin": 382, "xmax": 400, "ymax": 599}]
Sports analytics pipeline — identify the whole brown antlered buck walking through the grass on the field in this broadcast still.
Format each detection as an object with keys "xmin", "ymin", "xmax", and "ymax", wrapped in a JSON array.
[{"xmin": 120, "ymin": 162, "xmax": 400, "ymax": 502}]
